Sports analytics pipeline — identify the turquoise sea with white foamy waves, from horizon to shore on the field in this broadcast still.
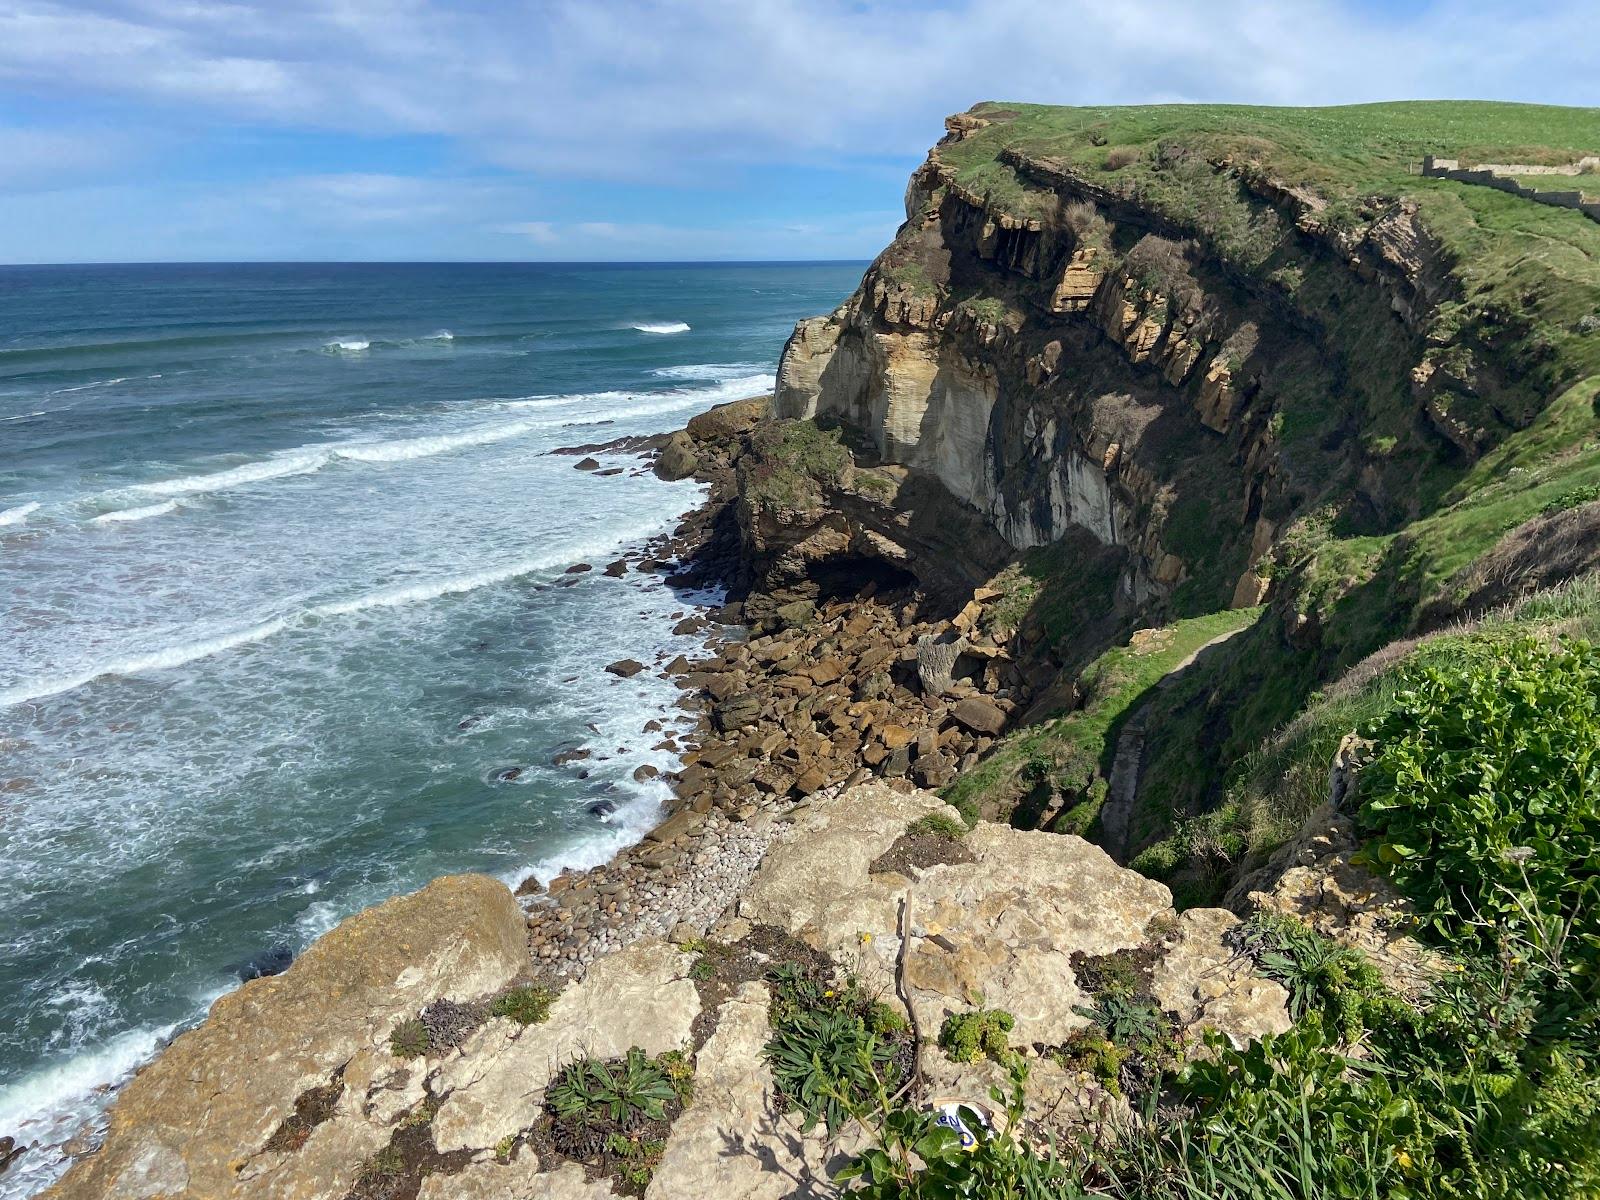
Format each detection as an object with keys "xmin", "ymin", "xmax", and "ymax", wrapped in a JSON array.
[{"xmin": 0, "ymin": 264, "xmax": 861, "ymax": 1197}]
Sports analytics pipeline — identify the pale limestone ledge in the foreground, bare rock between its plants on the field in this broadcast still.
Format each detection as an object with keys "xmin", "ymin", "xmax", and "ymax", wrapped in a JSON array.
[{"xmin": 46, "ymin": 782, "xmax": 1288, "ymax": 1200}]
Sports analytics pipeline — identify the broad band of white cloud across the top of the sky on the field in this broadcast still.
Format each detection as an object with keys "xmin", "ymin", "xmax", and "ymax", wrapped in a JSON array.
[{"xmin": 0, "ymin": 0, "xmax": 1600, "ymax": 182}]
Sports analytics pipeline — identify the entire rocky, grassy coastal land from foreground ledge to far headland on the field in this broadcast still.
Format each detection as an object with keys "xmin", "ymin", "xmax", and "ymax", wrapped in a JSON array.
[{"xmin": 28, "ymin": 104, "xmax": 1600, "ymax": 1200}]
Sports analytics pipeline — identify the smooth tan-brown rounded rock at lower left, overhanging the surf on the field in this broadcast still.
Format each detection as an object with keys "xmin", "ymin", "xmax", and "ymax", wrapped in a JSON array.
[{"xmin": 45, "ymin": 875, "xmax": 528, "ymax": 1200}]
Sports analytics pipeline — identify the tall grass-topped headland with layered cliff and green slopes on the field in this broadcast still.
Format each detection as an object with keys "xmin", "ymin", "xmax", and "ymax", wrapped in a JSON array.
[{"xmin": 761, "ymin": 104, "xmax": 1600, "ymax": 886}]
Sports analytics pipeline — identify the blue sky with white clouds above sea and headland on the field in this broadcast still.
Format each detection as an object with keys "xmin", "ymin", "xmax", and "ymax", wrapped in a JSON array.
[{"xmin": 0, "ymin": 0, "xmax": 1600, "ymax": 262}]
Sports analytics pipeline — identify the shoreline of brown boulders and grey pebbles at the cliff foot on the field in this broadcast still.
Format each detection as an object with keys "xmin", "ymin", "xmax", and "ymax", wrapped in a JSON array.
[{"xmin": 518, "ymin": 402, "xmax": 1026, "ymax": 979}]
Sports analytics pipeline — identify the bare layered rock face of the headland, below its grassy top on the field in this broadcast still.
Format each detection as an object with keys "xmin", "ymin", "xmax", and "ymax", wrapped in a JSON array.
[{"xmin": 776, "ymin": 114, "xmax": 1486, "ymax": 624}]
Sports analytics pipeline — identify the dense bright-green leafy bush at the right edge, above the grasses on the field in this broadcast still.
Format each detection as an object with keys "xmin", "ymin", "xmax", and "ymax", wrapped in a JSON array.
[{"xmin": 1360, "ymin": 635, "xmax": 1600, "ymax": 976}]
